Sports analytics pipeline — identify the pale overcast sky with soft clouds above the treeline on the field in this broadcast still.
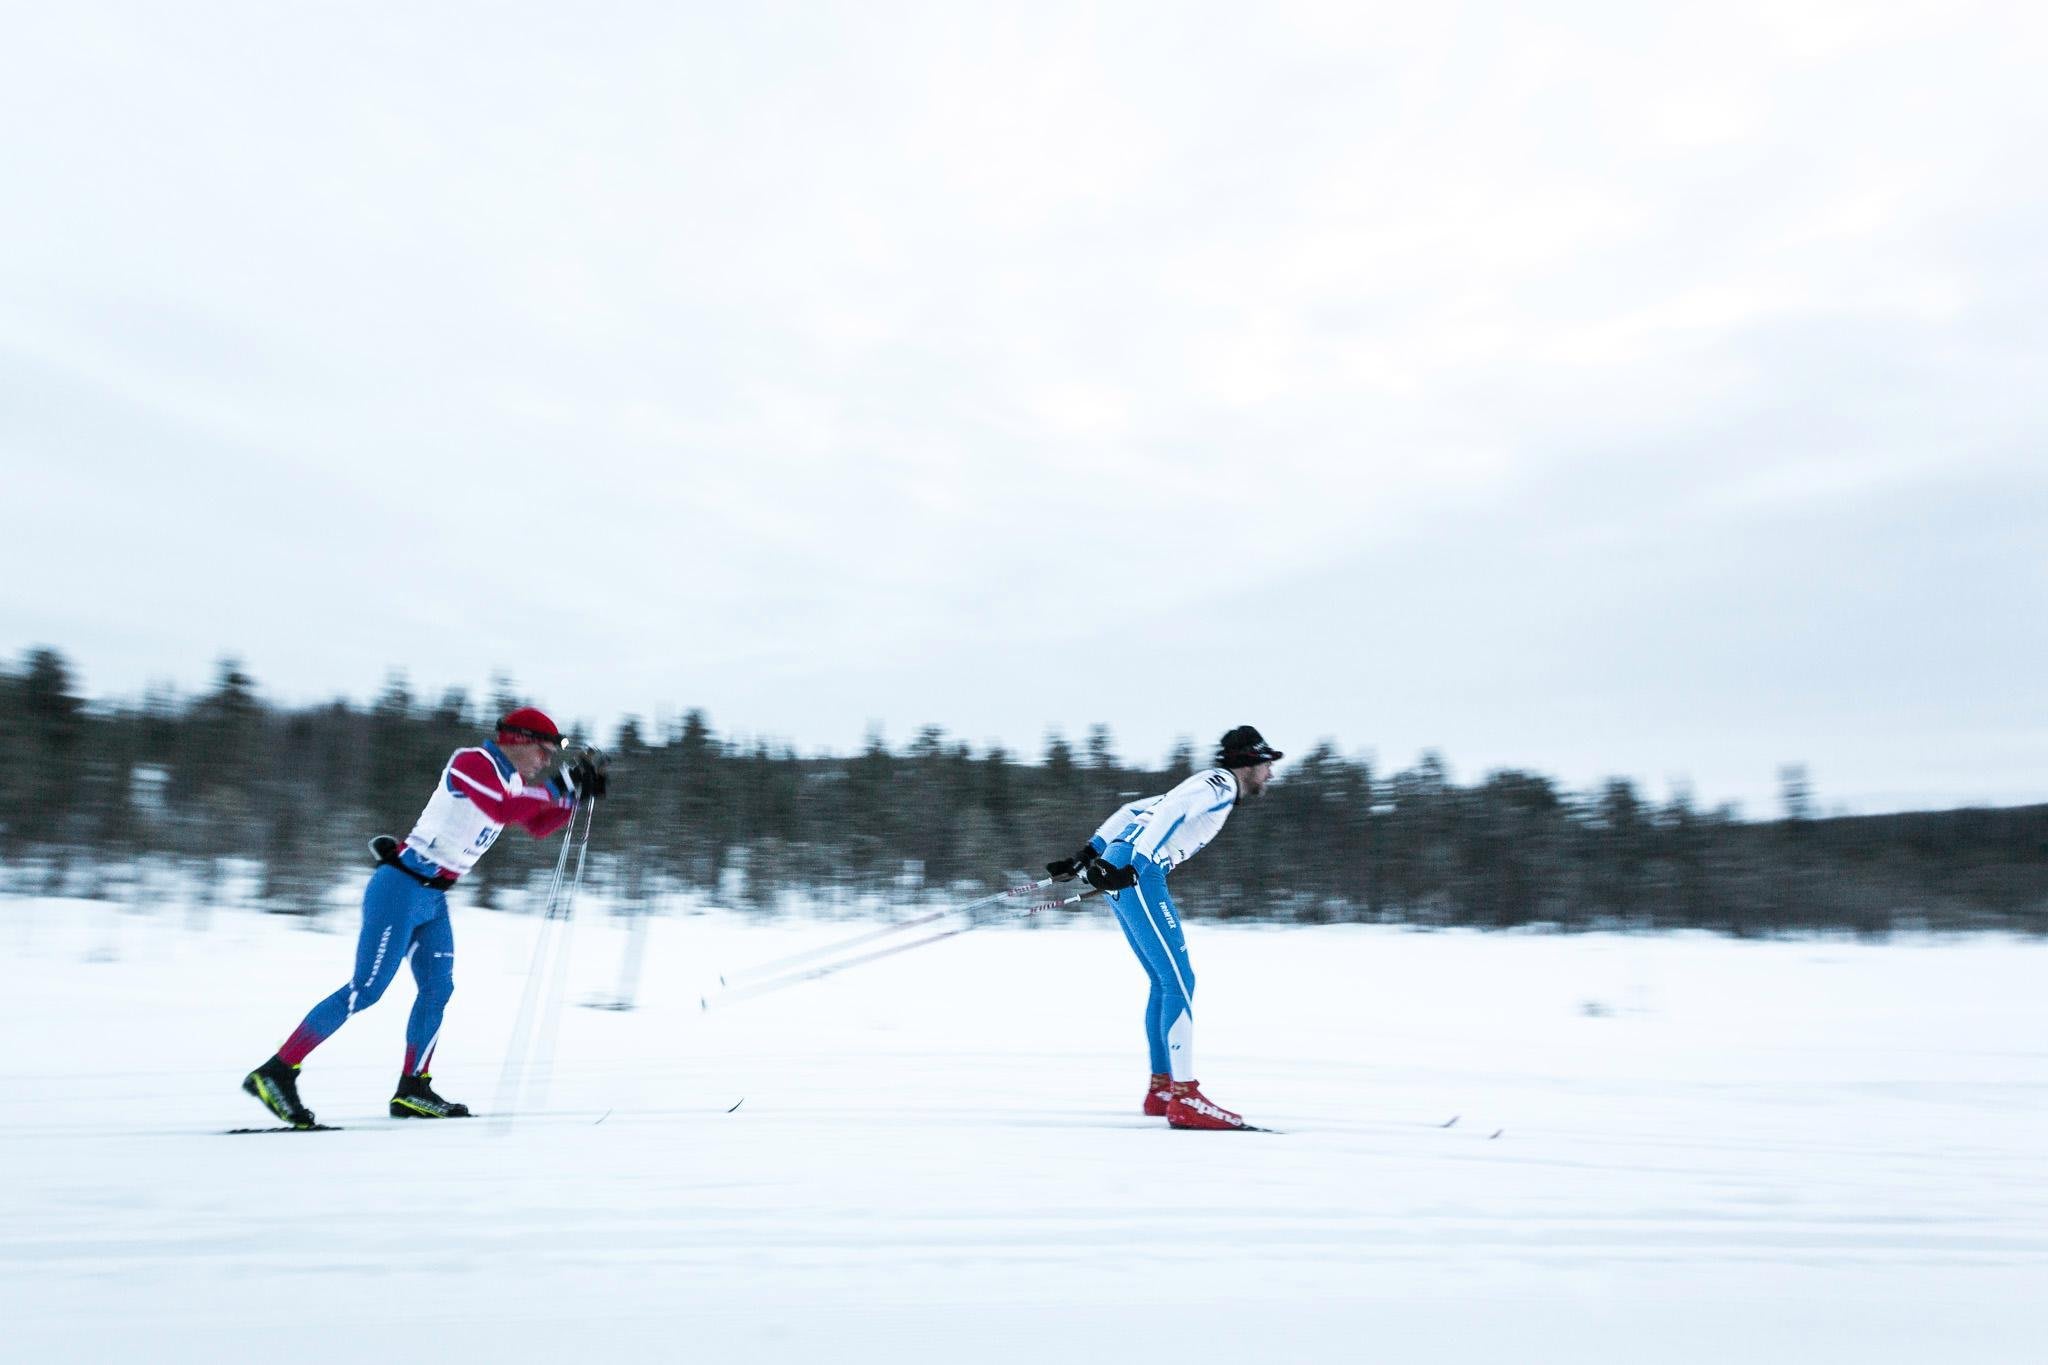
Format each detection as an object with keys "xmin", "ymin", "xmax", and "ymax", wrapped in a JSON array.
[{"xmin": 0, "ymin": 0, "xmax": 2048, "ymax": 817}]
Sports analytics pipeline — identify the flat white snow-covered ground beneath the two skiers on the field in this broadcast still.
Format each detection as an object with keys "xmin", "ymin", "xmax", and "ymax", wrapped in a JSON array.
[{"xmin": 0, "ymin": 900, "xmax": 2048, "ymax": 1365}]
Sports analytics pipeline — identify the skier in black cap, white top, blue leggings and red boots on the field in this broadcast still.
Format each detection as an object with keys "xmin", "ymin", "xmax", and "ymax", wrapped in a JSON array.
[{"xmin": 1047, "ymin": 724, "xmax": 1284, "ymax": 1128}]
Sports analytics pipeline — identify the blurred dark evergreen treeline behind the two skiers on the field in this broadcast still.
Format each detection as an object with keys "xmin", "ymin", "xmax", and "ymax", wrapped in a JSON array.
[{"xmin": 0, "ymin": 649, "xmax": 2048, "ymax": 933}]
